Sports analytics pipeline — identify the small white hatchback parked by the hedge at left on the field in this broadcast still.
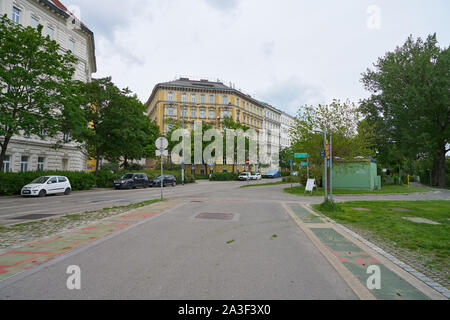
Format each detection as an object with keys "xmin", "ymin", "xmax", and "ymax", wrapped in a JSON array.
[{"xmin": 20, "ymin": 176, "xmax": 72, "ymax": 197}]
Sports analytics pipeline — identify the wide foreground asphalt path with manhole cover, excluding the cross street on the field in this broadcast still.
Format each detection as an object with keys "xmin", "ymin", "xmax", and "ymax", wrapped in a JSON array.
[{"xmin": 0, "ymin": 191, "xmax": 357, "ymax": 300}]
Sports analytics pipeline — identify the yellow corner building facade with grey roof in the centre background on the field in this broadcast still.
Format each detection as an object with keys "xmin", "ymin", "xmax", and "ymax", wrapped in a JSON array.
[{"xmin": 146, "ymin": 78, "xmax": 264, "ymax": 174}]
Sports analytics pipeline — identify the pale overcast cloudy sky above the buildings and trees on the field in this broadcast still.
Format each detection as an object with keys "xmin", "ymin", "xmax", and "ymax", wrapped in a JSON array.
[{"xmin": 63, "ymin": 0, "xmax": 450, "ymax": 115}]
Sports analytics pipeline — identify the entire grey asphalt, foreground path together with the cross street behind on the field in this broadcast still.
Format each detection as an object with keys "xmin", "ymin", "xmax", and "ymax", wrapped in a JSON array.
[{"xmin": 0, "ymin": 181, "xmax": 450, "ymax": 300}]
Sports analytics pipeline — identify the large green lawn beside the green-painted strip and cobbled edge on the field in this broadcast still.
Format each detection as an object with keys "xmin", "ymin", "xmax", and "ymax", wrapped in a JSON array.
[{"xmin": 313, "ymin": 200, "xmax": 450, "ymax": 280}]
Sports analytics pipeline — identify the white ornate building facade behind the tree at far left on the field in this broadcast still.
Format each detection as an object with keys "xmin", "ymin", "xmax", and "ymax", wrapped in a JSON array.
[{"xmin": 0, "ymin": 0, "xmax": 97, "ymax": 172}]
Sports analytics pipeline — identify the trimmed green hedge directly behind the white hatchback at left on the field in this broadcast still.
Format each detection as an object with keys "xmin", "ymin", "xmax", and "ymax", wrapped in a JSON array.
[{"xmin": 0, "ymin": 171, "xmax": 96, "ymax": 195}]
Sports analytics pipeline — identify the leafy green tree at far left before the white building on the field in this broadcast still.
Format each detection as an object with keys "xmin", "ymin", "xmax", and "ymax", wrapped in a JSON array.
[{"xmin": 0, "ymin": 15, "xmax": 83, "ymax": 168}]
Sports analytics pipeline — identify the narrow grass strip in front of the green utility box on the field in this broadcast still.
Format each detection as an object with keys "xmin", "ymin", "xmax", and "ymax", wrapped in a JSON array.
[{"xmin": 284, "ymin": 185, "xmax": 433, "ymax": 196}]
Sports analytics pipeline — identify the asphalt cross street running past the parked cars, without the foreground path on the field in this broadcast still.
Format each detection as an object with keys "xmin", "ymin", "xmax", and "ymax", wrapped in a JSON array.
[{"xmin": 0, "ymin": 179, "xmax": 450, "ymax": 225}]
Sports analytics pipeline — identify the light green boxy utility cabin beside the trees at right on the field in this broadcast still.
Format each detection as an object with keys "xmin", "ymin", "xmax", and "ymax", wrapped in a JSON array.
[{"xmin": 333, "ymin": 158, "xmax": 381, "ymax": 191}]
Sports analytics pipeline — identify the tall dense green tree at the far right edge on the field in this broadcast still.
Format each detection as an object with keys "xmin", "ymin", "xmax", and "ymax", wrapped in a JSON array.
[{"xmin": 362, "ymin": 34, "xmax": 450, "ymax": 187}]
